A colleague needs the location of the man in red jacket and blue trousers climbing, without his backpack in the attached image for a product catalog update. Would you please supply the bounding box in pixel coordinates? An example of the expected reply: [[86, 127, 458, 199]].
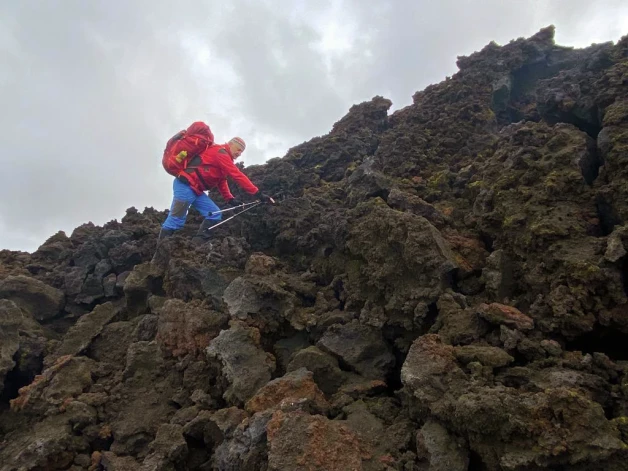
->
[[159, 137, 273, 240]]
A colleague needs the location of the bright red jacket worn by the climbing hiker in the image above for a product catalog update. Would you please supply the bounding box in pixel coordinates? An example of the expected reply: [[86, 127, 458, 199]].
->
[[181, 144, 258, 201]]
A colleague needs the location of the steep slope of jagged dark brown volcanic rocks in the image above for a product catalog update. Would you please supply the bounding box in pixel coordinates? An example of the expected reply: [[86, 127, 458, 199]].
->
[[0, 27, 628, 471]]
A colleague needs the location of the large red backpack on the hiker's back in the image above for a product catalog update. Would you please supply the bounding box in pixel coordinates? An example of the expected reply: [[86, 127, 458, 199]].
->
[[161, 121, 214, 177]]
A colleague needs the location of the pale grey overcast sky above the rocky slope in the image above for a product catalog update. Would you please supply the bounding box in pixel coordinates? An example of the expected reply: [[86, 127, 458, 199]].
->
[[0, 0, 628, 252]]
